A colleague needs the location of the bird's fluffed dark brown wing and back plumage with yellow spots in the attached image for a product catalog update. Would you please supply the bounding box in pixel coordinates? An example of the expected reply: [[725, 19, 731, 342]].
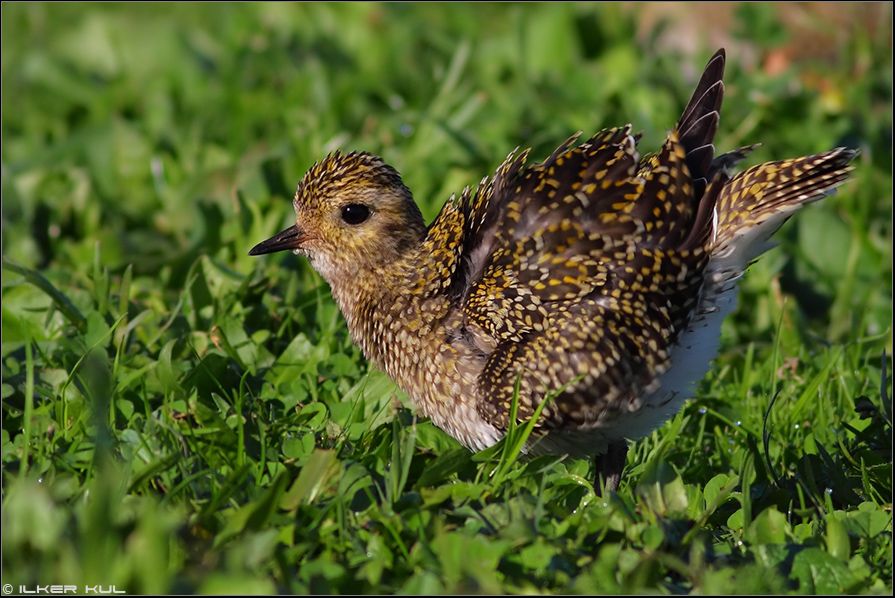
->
[[460, 127, 707, 426]]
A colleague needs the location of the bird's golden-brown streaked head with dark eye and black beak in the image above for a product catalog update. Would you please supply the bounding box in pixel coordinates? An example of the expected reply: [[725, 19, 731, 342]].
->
[[249, 152, 426, 285]]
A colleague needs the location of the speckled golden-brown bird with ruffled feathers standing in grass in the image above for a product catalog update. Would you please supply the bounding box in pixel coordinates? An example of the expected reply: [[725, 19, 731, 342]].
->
[[249, 48, 857, 492]]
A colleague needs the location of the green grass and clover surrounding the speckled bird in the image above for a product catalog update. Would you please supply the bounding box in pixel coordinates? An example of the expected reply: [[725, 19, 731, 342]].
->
[[2, 3, 892, 594]]
